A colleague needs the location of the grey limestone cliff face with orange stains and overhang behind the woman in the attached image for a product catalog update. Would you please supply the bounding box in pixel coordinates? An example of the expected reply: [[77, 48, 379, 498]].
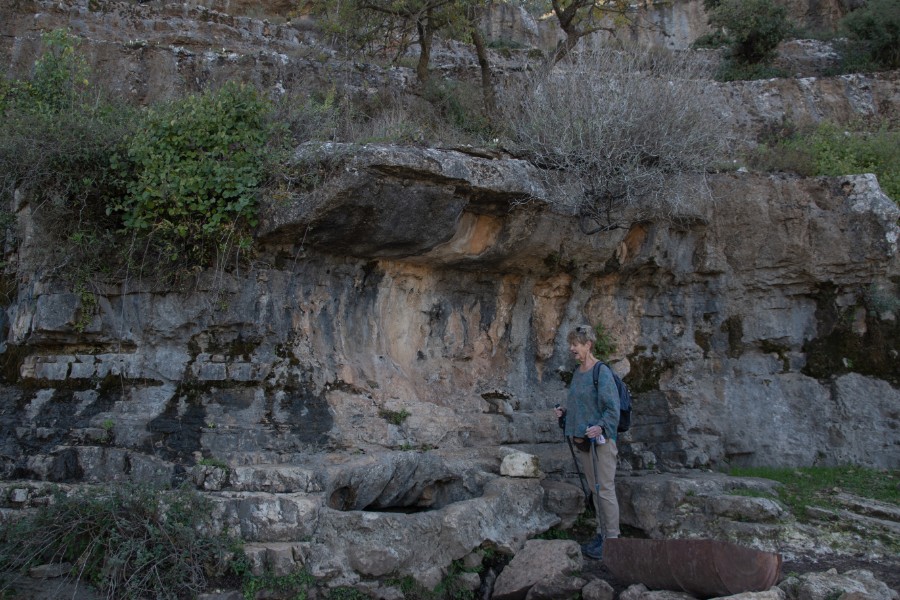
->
[[3, 141, 900, 480]]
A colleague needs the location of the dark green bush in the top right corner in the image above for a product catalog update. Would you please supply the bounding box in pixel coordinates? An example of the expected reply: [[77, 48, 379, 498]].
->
[[841, 0, 900, 69]]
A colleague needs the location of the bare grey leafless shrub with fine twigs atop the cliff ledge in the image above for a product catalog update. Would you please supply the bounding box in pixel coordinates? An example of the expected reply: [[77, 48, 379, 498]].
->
[[501, 47, 723, 233]]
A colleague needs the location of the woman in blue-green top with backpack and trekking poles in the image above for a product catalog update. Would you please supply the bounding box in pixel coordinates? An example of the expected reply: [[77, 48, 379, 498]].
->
[[556, 325, 619, 559]]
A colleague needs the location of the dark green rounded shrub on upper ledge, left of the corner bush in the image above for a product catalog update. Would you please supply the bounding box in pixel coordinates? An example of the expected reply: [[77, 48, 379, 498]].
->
[[709, 0, 792, 64]]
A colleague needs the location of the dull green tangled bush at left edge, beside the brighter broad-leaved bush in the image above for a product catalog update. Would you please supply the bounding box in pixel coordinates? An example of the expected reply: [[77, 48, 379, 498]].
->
[[0, 30, 136, 273]]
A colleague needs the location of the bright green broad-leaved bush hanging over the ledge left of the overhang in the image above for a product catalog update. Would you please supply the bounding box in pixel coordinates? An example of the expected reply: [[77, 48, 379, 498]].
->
[[109, 83, 272, 266]]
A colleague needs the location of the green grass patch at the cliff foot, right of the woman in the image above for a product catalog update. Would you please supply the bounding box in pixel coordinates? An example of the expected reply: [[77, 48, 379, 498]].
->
[[729, 466, 900, 519]]
